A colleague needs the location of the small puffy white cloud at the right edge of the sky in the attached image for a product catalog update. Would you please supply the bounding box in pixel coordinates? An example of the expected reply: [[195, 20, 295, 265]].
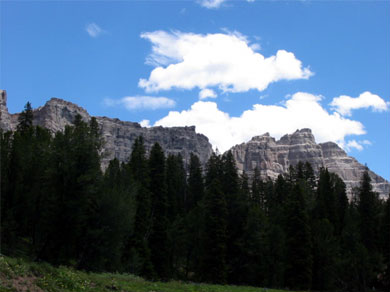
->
[[330, 91, 390, 116]]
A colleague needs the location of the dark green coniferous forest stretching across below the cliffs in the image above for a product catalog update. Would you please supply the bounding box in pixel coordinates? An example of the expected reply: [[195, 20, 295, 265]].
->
[[0, 104, 390, 291]]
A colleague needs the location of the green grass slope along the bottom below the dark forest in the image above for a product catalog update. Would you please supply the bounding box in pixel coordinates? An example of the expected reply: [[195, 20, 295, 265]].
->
[[0, 256, 292, 292]]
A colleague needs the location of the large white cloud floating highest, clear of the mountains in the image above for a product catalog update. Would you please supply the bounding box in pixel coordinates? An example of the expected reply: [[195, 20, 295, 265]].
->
[[138, 31, 313, 96]]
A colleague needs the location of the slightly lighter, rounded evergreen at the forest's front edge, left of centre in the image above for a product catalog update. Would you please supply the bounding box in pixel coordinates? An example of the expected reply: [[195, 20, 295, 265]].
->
[[79, 159, 135, 271]]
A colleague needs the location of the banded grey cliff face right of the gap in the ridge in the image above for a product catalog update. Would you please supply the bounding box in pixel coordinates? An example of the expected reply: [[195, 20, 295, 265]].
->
[[231, 129, 390, 197]]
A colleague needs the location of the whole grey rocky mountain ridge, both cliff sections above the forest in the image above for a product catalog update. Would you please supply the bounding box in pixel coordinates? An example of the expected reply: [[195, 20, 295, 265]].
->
[[0, 90, 390, 197]]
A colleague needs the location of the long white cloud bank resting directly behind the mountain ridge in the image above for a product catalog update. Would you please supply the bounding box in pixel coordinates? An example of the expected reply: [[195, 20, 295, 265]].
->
[[155, 92, 365, 151]]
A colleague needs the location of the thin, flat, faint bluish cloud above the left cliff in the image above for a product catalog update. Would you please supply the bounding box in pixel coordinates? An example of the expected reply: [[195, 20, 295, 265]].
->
[[104, 96, 176, 110]]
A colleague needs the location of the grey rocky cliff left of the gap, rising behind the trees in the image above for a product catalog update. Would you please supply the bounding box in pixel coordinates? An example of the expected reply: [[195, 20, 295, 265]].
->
[[0, 91, 212, 167]]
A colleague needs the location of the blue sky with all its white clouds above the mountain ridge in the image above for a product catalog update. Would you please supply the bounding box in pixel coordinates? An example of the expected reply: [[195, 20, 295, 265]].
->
[[0, 0, 390, 180]]
